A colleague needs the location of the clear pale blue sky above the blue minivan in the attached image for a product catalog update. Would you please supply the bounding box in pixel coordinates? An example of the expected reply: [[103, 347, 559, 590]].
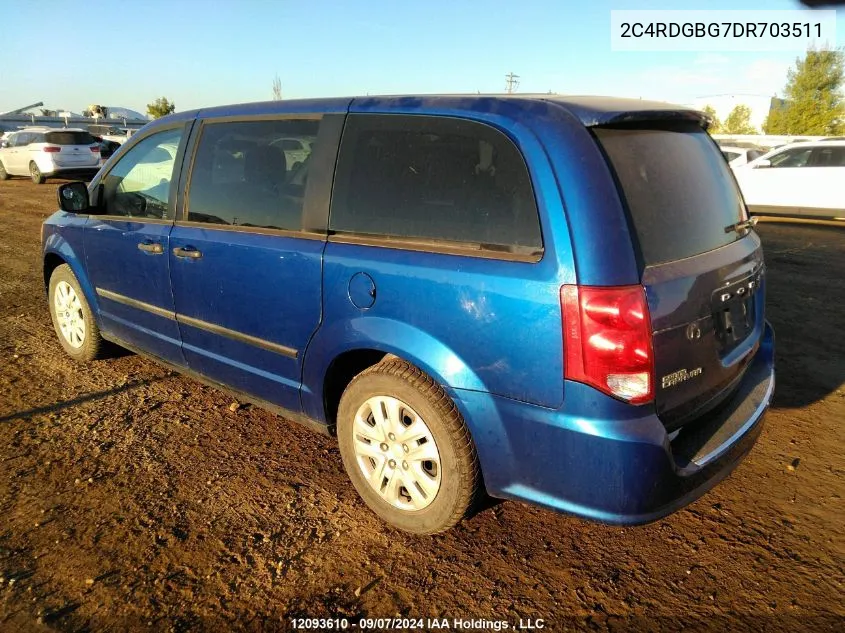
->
[[0, 0, 845, 112]]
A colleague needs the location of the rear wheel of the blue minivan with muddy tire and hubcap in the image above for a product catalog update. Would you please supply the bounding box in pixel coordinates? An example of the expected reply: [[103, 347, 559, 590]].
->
[[337, 357, 483, 534]]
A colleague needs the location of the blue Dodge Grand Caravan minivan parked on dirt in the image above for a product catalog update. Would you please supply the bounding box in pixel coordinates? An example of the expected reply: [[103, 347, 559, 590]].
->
[[42, 95, 774, 534]]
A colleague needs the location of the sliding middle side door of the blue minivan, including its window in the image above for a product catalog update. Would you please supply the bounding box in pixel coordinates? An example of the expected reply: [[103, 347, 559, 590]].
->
[[168, 117, 340, 411]]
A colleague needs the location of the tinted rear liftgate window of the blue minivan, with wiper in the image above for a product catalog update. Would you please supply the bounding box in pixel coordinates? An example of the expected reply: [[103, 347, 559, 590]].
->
[[593, 124, 745, 266]]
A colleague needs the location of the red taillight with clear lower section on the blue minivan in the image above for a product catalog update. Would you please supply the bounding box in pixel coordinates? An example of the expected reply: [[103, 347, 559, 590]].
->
[[560, 285, 654, 404]]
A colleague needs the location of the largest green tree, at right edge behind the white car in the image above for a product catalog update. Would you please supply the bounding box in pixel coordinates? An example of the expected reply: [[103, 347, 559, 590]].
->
[[765, 49, 845, 136]]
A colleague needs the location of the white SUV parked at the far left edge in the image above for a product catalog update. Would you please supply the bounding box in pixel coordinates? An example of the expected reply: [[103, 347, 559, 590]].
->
[[0, 127, 100, 185]]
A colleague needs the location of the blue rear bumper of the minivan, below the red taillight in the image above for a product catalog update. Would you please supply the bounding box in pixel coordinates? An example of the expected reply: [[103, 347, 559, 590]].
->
[[455, 323, 775, 525]]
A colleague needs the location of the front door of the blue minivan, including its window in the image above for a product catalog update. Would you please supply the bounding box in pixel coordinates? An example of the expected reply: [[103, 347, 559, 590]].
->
[[84, 122, 191, 364]]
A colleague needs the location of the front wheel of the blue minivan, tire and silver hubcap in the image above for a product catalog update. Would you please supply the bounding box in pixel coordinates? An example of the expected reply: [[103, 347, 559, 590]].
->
[[48, 264, 104, 363]]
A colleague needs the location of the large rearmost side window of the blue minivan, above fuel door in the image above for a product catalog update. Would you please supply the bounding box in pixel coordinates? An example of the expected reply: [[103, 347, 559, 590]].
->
[[330, 115, 542, 252]]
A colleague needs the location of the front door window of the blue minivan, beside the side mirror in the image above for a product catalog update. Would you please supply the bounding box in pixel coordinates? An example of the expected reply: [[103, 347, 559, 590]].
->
[[100, 128, 182, 218]]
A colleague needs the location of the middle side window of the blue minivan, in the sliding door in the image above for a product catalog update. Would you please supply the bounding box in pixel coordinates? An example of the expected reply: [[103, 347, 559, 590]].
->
[[188, 120, 320, 230]]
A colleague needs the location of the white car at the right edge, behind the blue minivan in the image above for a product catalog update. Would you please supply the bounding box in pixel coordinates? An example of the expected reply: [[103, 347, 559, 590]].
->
[[734, 141, 845, 218]]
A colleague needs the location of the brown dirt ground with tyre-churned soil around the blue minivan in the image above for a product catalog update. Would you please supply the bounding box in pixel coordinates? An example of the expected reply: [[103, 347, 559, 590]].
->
[[0, 180, 845, 631]]
